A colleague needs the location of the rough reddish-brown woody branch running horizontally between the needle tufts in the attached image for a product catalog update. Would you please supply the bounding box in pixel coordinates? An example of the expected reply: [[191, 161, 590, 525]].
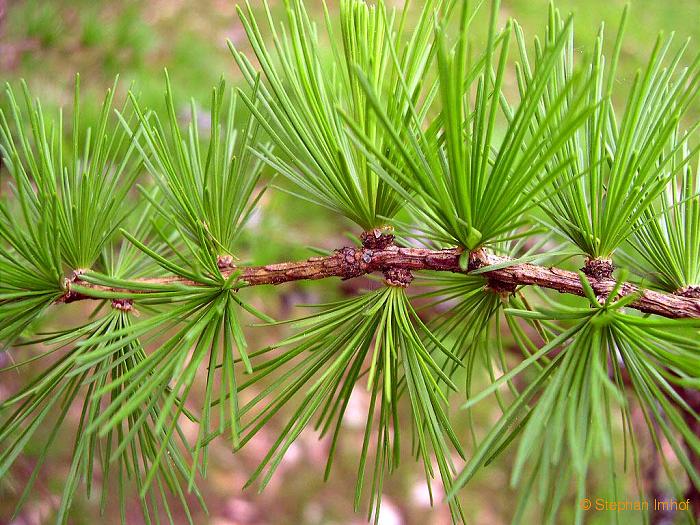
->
[[57, 244, 700, 318]]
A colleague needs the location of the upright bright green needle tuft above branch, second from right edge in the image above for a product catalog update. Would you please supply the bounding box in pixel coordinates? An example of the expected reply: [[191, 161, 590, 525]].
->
[[532, 4, 700, 258]]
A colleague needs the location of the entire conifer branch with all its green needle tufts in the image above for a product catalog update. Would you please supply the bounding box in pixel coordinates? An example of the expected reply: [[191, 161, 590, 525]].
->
[[0, 0, 700, 523]]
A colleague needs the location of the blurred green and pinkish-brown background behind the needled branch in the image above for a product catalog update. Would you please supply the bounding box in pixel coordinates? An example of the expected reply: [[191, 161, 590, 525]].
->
[[0, 0, 700, 525]]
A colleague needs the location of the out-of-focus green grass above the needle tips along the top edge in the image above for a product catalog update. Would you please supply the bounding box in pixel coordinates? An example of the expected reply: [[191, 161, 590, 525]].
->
[[0, 0, 700, 119]]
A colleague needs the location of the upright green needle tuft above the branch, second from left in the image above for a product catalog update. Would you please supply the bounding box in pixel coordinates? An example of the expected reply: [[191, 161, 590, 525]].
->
[[126, 72, 262, 260]]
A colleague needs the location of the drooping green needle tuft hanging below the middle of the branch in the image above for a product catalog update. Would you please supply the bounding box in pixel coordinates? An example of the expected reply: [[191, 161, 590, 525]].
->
[[243, 286, 464, 520]]
